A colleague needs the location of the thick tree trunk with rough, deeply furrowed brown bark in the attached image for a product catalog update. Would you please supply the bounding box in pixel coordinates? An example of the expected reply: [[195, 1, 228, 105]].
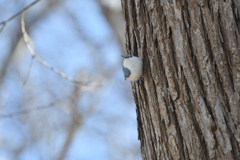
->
[[122, 0, 240, 160]]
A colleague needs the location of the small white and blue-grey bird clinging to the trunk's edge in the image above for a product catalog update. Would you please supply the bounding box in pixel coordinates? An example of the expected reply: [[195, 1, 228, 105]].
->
[[122, 55, 143, 81]]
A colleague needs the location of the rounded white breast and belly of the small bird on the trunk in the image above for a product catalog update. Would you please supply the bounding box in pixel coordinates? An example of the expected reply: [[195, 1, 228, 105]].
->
[[123, 56, 143, 81]]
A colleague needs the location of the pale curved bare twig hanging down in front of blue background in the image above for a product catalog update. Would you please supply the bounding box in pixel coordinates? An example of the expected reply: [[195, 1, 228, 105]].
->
[[21, 12, 81, 84]]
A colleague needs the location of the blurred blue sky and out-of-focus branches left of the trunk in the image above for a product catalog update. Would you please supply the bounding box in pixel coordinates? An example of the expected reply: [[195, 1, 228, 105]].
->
[[0, 0, 141, 160]]
